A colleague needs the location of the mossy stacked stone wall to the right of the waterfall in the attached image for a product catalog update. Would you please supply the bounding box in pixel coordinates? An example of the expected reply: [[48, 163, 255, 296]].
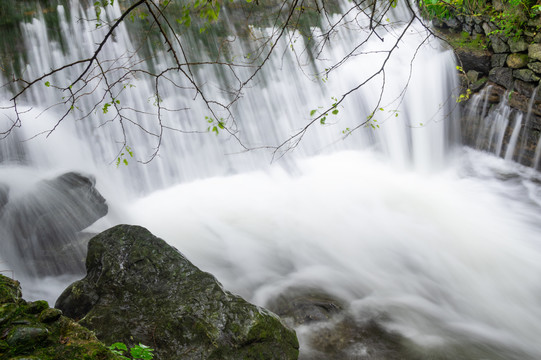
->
[[433, 10, 541, 169]]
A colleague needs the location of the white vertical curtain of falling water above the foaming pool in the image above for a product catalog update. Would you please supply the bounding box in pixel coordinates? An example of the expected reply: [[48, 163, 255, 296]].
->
[[3, 1, 457, 192]]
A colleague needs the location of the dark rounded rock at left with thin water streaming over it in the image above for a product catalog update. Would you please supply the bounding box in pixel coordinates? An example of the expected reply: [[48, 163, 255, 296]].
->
[[0, 172, 108, 276]]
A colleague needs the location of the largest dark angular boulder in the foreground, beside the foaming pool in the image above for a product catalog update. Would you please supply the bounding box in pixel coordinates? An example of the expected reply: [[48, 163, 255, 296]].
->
[[56, 225, 299, 360]]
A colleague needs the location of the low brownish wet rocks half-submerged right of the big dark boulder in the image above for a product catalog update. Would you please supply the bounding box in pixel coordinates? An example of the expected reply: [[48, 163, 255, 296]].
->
[[266, 288, 419, 360]]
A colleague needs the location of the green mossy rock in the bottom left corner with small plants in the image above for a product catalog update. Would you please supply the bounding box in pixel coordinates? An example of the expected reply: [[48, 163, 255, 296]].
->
[[0, 275, 120, 360]]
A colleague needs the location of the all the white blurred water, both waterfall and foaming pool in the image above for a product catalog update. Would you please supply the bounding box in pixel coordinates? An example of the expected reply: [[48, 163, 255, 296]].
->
[[0, 1, 541, 359]]
